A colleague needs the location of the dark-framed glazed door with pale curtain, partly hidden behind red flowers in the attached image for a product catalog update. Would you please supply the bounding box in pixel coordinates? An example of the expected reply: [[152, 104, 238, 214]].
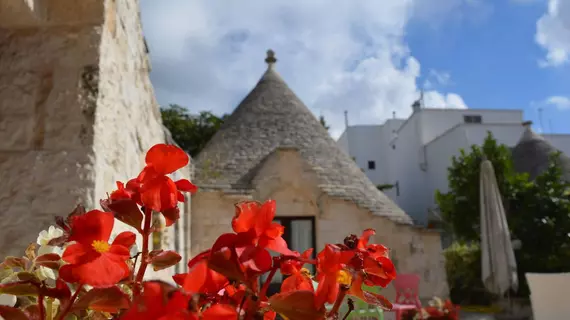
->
[[260, 217, 317, 296]]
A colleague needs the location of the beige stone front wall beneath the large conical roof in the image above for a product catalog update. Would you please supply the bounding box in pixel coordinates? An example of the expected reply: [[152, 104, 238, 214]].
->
[[191, 149, 448, 299]]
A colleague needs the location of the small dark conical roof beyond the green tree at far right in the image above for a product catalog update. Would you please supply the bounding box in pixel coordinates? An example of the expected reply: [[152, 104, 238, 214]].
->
[[512, 125, 570, 181]]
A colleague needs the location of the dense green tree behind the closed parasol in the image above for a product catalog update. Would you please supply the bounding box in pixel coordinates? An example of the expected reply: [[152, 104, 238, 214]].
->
[[436, 134, 570, 300]]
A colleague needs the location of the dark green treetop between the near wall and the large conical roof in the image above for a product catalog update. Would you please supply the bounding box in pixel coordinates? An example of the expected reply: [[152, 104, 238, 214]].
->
[[160, 104, 228, 157]]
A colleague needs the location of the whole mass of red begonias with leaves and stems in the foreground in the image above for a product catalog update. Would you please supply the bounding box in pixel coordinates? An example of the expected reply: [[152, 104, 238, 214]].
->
[[0, 144, 396, 320]]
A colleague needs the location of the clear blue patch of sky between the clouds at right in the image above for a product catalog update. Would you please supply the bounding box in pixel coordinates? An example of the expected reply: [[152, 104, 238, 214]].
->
[[406, 1, 570, 133]]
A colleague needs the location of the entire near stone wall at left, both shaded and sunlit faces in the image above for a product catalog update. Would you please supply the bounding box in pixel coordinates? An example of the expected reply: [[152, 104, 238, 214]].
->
[[0, 0, 190, 275]]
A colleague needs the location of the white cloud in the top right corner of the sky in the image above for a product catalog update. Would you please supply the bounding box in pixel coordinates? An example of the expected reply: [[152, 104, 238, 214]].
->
[[535, 0, 570, 67]]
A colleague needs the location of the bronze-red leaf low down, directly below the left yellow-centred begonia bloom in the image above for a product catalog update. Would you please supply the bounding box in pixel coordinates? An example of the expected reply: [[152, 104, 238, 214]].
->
[[72, 287, 130, 313]]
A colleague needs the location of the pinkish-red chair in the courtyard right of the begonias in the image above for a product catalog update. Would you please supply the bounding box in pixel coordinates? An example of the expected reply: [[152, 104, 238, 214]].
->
[[386, 274, 423, 320]]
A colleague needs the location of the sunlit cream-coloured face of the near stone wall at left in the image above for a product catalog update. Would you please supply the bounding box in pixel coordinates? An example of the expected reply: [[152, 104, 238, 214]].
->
[[93, 0, 190, 280]]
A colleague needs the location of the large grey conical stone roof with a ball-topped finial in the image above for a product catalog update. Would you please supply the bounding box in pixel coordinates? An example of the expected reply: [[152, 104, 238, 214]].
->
[[194, 51, 412, 224]]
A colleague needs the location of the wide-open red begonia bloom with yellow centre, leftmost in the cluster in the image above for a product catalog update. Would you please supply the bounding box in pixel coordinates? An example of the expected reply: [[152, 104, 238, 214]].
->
[[59, 210, 136, 287]]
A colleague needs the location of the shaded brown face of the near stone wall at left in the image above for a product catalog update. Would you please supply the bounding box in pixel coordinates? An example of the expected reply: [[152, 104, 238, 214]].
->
[[0, 0, 100, 256]]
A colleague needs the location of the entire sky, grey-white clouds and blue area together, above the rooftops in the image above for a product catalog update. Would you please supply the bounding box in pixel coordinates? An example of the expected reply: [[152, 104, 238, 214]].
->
[[141, 0, 570, 136]]
